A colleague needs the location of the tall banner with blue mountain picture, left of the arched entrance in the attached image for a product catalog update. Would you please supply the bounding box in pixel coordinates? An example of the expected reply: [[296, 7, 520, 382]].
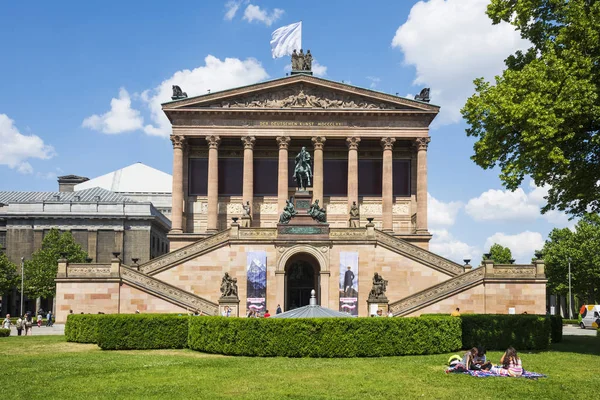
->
[[246, 251, 267, 314]]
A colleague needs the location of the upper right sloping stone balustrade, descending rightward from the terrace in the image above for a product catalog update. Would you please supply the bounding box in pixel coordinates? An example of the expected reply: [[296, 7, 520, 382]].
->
[[375, 230, 465, 276]]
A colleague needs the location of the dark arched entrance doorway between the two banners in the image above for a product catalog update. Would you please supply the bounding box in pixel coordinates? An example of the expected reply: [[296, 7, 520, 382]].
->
[[285, 253, 321, 311]]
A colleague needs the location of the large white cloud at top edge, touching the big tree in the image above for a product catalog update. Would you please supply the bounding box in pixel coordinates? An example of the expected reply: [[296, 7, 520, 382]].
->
[[392, 0, 529, 125]]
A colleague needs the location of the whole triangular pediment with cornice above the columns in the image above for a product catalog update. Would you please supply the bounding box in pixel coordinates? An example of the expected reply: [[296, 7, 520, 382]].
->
[[163, 75, 439, 114]]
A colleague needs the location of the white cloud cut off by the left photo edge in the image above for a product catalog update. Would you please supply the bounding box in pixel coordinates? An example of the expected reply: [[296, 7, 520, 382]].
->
[[0, 114, 55, 174]]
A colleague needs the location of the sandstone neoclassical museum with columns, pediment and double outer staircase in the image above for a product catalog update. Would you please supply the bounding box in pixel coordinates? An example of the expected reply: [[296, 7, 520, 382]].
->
[[56, 63, 546, 321]]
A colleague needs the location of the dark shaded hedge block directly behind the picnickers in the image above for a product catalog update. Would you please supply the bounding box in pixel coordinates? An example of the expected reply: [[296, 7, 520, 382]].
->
[[460, 314, 562, 350]]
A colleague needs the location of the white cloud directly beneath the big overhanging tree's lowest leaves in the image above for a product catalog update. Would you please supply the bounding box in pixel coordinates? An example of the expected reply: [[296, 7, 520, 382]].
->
[[465, 181, 576, 227]]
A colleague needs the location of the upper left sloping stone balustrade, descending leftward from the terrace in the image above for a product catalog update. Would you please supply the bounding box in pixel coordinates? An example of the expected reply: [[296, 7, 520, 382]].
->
[[139, 229, 230, 275]]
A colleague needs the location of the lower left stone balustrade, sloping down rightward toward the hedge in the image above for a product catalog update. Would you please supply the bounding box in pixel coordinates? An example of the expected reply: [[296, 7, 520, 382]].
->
[[121, 265, 219, 315]]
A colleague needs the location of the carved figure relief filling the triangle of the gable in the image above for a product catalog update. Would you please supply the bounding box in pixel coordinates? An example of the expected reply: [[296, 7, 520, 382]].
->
[[200, 86, 406, 110]]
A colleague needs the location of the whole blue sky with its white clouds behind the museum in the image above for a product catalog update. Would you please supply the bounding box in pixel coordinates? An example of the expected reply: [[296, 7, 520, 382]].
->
[[0, 0, 573, 262]]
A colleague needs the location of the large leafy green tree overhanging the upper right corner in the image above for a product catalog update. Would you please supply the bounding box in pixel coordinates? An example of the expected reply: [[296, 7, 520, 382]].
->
[[462, 0, 600, 216]]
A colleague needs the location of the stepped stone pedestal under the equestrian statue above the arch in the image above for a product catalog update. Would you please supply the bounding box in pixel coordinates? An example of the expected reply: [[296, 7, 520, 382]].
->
[[277, 190, 329, 240]]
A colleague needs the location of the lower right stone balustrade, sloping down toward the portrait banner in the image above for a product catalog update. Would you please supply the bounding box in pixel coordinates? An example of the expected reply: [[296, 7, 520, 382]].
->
[[389, 267, 485, 317]]
